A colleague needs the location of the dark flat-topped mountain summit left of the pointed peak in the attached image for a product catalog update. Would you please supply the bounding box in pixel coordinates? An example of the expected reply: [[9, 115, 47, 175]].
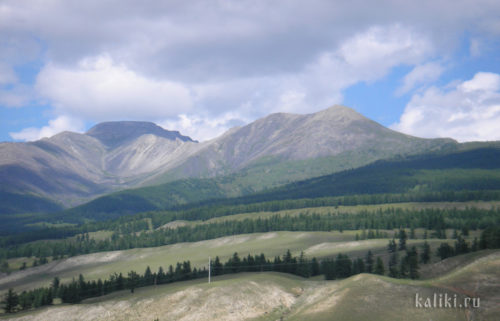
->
[[86, 121, 194, 147]]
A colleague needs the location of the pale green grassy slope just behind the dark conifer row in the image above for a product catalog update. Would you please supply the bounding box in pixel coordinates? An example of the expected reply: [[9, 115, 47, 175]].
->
[[0, 231, 451, 293]]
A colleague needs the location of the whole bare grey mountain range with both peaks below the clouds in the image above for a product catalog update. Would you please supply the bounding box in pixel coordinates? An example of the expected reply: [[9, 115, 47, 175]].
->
[[0, 106, 459, 212]]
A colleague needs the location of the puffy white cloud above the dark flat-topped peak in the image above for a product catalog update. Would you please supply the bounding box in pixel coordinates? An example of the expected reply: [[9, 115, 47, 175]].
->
[[36, 55, 192, 121]]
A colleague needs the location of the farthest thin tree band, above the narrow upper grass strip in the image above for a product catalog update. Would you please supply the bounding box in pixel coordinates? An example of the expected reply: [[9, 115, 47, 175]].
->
[[0, 190, 500, 248]]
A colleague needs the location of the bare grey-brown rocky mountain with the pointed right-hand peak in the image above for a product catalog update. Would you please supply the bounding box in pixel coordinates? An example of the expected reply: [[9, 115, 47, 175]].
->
[[146, 106, 456, 182]]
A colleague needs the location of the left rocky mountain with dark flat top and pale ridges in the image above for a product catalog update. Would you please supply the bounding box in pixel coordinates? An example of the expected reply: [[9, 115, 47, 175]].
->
[[0, 122, 196, 205]]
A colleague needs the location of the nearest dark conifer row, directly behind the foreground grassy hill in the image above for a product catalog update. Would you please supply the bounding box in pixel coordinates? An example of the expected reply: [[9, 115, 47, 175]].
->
[[4, 222, 500, 313]]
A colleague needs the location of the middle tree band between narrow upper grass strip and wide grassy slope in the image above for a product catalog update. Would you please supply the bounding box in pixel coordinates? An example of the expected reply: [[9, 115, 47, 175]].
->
[[0, 208, 500, 261]]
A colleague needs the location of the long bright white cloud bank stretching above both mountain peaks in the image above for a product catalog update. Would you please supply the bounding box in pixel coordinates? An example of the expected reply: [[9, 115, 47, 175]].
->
[[23, 25, 432, 140]]
